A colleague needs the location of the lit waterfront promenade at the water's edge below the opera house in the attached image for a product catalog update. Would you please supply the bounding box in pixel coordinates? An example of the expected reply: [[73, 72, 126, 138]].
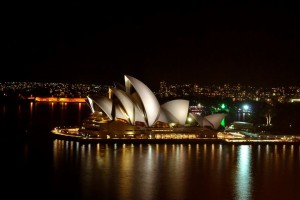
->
[[51, 127, 300, 145]]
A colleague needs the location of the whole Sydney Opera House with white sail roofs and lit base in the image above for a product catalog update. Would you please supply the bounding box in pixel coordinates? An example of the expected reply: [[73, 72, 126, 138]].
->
[[79, 75, 226, 139]]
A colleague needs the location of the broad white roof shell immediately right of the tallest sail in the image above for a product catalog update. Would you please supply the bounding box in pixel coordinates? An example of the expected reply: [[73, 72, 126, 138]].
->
[[161, 99, 189, 125]]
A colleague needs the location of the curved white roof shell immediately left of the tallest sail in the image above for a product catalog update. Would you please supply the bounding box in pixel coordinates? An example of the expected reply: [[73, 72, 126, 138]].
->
[[110, 88, 135, 124]]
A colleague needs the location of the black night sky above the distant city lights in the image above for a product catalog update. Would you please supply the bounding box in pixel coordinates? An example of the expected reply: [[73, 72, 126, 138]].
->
[[0, 1, 300, 88]]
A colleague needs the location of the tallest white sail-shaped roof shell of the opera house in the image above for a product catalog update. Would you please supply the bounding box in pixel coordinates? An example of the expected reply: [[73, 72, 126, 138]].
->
[[125, 75, 160, 127]]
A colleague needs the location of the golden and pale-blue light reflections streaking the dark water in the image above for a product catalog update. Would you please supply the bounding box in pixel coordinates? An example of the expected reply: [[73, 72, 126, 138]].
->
[[53, 140, 300, 199]]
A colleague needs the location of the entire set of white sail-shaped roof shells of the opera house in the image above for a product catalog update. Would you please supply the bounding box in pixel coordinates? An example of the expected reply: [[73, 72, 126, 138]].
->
[[86, 76, 226, 130]]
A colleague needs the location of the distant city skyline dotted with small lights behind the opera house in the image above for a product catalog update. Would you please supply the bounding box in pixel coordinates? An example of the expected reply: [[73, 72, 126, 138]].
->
[[0, 81, 300, 104]]
